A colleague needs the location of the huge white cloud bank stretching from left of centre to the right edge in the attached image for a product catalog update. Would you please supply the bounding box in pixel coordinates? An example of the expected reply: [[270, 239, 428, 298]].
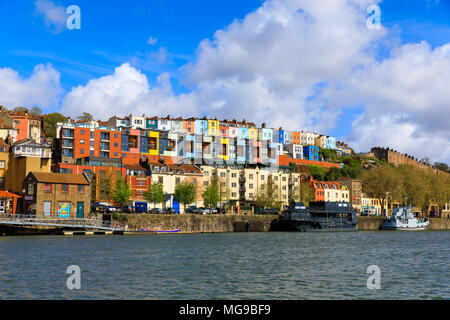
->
[[56, 0, 450, 162]]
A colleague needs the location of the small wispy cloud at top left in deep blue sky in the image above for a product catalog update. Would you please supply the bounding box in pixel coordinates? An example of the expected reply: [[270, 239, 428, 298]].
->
[[34, 0, 67, 33]]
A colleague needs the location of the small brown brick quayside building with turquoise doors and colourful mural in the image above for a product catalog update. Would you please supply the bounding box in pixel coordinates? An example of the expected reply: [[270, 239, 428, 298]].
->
[[23, 171, 91, 219]]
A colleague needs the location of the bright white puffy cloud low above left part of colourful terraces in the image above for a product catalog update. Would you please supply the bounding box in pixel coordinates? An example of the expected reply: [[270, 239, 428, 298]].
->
[[61, 63, 199, 119]]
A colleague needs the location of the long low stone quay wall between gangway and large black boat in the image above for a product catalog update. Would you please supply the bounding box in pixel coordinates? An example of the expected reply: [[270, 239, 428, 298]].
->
[[118, 214, 278, 233]]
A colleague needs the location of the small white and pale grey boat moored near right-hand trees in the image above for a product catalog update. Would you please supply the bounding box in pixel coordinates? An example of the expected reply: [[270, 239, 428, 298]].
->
[[382, 207, 430, 230]]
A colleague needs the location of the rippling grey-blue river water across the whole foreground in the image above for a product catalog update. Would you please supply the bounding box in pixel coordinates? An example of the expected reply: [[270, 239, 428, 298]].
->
[[0, 231, 450, 300]]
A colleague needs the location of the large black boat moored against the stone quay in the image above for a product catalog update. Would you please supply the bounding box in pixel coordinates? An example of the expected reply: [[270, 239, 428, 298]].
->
[[271, 201, 356, 231]]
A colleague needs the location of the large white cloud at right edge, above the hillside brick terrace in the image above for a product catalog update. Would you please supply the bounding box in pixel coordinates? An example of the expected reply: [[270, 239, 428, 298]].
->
[[326, 42, 450, 162]]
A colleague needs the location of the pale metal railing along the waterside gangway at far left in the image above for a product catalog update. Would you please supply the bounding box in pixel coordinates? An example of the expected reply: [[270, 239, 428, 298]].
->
[[0, 214, 123, 230]]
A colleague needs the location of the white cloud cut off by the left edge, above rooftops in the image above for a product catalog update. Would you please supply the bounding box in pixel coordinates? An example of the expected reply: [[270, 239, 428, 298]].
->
[[0, 64, 63, 108]]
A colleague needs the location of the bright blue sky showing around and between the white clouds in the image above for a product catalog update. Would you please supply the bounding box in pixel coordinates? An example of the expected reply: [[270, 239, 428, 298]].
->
[[0, 0, 450, 159]]
